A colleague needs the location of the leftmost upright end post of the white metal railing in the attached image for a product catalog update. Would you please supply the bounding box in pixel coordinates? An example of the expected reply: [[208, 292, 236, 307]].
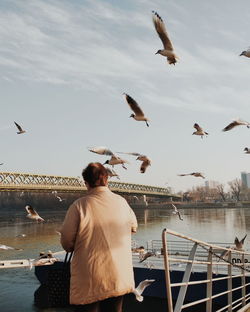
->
[[162, 229, 173, 312]]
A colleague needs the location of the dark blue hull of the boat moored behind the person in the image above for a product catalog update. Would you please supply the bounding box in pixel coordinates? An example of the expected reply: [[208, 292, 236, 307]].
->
[[35, 262, 250, 312]]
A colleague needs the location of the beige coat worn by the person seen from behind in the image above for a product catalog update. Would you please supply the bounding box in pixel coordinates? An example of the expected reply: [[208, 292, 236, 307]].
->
[[61, 186, 137, 305]]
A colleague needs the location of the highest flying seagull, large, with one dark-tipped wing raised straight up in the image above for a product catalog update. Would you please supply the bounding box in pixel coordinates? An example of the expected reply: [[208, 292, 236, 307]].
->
[[152, 11, 177, 65]]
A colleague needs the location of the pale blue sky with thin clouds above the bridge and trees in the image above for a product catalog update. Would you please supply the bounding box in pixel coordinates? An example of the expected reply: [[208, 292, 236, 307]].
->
[[0, 0, 250, 191]]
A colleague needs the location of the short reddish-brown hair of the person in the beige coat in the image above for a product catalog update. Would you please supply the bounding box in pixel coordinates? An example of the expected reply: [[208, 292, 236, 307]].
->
[[82, 163, 108, 188]]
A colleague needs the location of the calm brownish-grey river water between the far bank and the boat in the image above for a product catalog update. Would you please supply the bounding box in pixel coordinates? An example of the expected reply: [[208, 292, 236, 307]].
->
[[0, 207, 250, 312]]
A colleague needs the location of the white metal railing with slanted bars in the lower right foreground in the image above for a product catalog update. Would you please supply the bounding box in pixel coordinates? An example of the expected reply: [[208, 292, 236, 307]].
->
[[162, 229, 250, 312]]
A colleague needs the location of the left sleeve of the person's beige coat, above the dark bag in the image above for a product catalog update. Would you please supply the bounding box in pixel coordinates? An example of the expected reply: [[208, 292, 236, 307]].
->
[[60, 204, 80, 252]]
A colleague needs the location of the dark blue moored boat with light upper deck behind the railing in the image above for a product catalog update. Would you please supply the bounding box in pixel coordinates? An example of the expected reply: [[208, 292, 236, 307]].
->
[[35, 230, 250, 312]]
